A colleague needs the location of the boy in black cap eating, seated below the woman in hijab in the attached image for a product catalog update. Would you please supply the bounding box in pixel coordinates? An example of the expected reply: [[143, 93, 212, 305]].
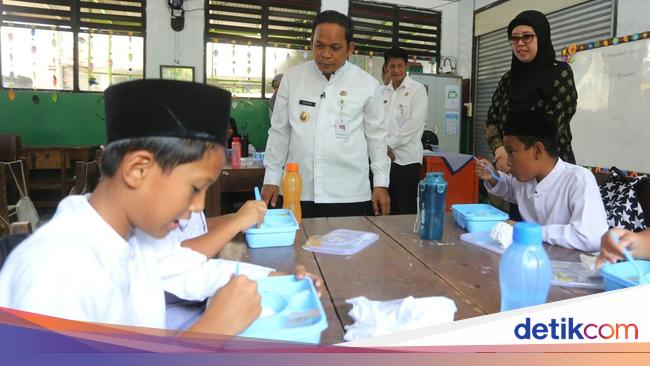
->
[[476, 111, 608, 252]]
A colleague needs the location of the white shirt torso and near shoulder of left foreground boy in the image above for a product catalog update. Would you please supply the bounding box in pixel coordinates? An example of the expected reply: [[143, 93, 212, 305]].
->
[[0, 195, 165, 328]]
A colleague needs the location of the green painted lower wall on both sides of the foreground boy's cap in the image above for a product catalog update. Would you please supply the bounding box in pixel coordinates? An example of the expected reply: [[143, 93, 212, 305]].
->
[[0, 89, 270, 150]]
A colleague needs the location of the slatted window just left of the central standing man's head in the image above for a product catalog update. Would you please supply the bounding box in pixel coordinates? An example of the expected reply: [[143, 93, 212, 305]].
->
[[205, 0, 320, 98]]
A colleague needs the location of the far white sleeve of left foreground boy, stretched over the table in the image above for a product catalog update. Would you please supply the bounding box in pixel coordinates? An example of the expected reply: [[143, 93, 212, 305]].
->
[[157, 247, 274, 301]]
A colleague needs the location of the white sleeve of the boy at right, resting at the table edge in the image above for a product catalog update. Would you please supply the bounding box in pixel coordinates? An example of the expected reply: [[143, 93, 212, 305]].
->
[[543, 173, 608, 252]]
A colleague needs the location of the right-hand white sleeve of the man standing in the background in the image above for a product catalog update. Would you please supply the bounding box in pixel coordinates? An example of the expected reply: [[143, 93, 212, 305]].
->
[[387, 85, 429, 149]]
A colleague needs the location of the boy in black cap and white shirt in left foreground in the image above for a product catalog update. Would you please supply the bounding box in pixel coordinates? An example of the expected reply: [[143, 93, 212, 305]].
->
[[0, 80, 318, 335]]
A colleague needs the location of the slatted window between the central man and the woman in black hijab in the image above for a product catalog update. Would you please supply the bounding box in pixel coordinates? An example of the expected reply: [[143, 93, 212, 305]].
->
[[349, 1, 441, 79]]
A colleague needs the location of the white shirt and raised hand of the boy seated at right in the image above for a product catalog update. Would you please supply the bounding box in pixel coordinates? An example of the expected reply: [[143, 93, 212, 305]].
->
[[484, 158, 609, 252]]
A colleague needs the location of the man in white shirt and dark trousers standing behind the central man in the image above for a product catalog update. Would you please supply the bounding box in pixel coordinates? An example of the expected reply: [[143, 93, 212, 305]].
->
[[382, 48, 429, 214]]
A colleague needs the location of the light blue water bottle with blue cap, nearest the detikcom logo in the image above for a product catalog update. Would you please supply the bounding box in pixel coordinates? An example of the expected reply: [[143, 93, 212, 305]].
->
[[499, 222, 551, 311]]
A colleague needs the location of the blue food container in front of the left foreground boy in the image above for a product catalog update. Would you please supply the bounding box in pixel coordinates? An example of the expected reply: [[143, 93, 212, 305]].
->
[[239, 275, 327, 344]]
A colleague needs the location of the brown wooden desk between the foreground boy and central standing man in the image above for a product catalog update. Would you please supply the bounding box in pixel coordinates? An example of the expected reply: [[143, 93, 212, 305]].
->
[[205, 159, 264, 217]]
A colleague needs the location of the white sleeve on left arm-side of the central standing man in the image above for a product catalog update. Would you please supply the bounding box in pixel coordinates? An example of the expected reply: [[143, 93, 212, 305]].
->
[[264, 73, 291, 186]]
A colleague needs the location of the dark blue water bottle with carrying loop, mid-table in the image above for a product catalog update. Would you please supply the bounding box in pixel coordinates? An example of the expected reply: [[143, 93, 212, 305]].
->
[[418, 172, 447, 240]]
